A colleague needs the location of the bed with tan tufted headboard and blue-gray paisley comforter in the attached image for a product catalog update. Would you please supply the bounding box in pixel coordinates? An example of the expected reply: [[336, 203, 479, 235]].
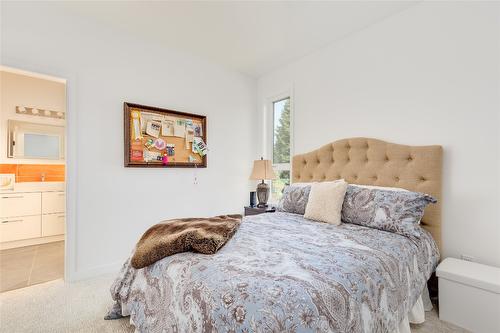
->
[[111, 138, 442, 332]]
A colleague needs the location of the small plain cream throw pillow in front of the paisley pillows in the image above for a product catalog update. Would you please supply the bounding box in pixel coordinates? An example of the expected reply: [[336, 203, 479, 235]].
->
[[304, 179, 347, 225]]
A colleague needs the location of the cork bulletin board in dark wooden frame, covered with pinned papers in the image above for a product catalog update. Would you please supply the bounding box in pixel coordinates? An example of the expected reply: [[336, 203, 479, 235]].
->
[[123, 102, 207, 168]]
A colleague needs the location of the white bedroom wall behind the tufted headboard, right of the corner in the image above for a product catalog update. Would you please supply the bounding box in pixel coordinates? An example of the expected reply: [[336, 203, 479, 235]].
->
[[258, 2, 500, 266]]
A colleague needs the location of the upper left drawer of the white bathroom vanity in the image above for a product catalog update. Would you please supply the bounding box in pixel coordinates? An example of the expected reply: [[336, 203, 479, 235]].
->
[[0, 193, 41, 218]]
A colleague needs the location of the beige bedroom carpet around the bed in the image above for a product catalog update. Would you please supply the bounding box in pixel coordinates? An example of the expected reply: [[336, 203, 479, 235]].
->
[[0, 275, 466, 333]]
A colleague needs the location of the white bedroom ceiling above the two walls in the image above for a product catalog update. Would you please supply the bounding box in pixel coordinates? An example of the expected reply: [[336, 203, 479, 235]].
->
[[60, 1, 416, 77]]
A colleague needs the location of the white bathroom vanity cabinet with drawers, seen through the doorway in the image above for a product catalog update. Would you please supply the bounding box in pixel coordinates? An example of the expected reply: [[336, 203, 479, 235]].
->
[[0, 184, 66, 249]]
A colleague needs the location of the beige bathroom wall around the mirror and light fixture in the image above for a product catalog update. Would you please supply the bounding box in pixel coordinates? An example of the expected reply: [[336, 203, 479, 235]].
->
[[0, 69, 66, 164]]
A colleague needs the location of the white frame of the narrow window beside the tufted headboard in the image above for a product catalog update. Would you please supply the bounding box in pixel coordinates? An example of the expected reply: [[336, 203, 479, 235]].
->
[[264, 88, 295, 204]]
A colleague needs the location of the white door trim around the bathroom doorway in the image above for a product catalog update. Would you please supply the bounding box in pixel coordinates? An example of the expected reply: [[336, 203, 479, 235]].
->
[[0, 57, 78, 282]]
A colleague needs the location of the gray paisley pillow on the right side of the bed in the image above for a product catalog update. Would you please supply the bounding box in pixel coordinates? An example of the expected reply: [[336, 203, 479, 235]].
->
[[342, 185, 437, 238]]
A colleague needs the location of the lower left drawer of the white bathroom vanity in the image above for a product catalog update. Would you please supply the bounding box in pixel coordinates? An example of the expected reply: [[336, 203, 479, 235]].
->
[[0, 215, 42, 242]]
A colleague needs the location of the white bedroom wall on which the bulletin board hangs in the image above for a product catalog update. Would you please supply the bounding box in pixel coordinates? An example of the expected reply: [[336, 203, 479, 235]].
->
[[0, 2, 256, 279]]
